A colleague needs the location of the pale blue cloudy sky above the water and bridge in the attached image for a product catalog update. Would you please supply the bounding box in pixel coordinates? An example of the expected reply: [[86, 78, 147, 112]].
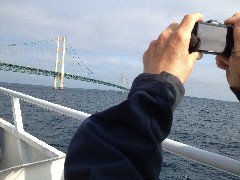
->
[[0, 0, 240, 101]]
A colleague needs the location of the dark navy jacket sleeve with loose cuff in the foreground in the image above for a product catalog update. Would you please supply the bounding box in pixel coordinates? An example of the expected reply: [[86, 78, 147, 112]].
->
[[64, 72, 184, 180]]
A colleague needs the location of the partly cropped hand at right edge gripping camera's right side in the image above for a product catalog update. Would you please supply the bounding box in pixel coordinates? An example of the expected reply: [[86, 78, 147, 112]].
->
[[216, 13, 240, 101]]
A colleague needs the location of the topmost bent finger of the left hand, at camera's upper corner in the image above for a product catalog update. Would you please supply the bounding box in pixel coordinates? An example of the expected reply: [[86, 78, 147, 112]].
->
[[179, 13, 203, 36]]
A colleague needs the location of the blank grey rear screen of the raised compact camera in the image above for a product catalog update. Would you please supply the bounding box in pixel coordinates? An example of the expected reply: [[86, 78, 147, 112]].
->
[[198, 23, 227, 53]]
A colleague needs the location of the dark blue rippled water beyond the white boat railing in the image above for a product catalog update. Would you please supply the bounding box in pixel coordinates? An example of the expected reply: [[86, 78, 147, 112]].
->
[[0, 83, 240, 180]]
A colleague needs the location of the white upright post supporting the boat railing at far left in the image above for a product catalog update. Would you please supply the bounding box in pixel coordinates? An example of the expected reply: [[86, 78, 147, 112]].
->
[[12, 97, 28, 164]]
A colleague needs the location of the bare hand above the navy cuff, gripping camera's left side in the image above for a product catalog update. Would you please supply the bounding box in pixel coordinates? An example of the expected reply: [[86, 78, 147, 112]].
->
[[143, 14, 203, 83]]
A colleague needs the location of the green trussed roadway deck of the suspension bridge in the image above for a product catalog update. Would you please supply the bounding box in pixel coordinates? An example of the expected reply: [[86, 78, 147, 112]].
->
[[0, 62, 129, 91]]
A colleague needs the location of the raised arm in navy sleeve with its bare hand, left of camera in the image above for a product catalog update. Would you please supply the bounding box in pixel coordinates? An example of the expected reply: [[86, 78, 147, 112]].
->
[[64, 13, 240, 180]]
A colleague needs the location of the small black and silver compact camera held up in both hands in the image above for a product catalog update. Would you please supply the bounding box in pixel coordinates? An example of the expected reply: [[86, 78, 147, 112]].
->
[[189, 20, 234, 57]]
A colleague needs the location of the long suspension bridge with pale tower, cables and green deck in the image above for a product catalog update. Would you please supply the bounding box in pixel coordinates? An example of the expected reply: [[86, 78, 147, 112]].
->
[[0, 36, 129, 91]]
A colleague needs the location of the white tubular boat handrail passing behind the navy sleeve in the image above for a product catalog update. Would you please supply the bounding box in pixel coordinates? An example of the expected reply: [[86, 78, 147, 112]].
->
[[0, 87, 240, 176]]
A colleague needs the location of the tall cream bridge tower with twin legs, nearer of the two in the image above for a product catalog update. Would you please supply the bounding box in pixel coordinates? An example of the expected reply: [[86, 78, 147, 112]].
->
[[53, 36, 66, 89]]
